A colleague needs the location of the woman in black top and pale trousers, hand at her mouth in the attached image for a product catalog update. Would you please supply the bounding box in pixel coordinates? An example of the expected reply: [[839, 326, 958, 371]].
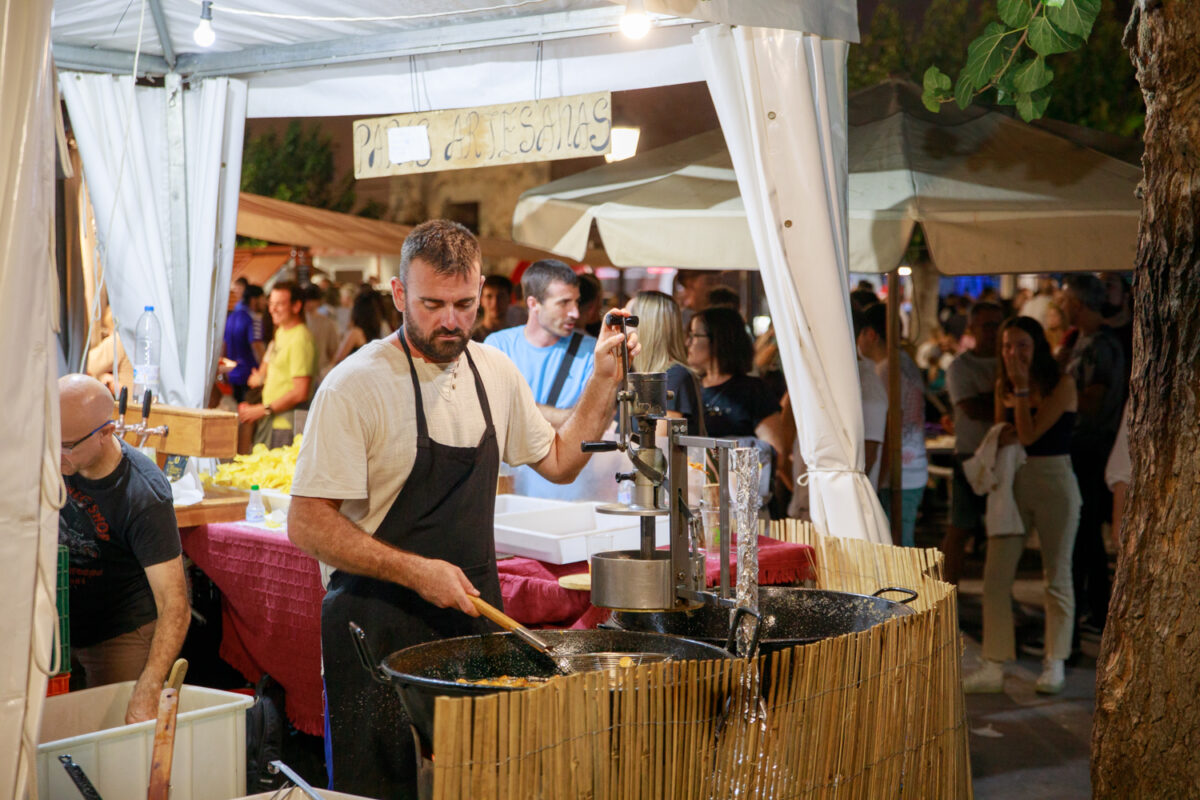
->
[[962, 317, 1081, 694]]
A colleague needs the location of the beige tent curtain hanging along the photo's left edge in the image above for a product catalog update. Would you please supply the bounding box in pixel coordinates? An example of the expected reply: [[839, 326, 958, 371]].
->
[[0, 0, 62, 798]]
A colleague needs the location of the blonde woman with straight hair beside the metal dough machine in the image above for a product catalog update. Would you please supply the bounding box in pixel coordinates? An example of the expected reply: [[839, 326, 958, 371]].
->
[[629, 291, 707, 437]]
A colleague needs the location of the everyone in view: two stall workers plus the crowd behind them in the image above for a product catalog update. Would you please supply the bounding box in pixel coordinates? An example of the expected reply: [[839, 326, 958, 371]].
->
[[59, 209, 1132, 796]]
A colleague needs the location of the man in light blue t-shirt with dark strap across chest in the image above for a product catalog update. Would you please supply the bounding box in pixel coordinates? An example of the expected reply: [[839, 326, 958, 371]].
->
[[484, 259, 596, 428]]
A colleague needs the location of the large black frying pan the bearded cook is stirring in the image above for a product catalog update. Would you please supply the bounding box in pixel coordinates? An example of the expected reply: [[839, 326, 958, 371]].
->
[[350, 622, 733, 750]]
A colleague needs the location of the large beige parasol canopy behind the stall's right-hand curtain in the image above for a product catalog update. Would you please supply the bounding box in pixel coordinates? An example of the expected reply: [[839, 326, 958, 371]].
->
[[512, 82, 1141, 275]]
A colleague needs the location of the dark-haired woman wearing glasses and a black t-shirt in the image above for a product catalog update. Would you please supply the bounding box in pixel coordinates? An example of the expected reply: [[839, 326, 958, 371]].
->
[[686, 308, 787, 465]]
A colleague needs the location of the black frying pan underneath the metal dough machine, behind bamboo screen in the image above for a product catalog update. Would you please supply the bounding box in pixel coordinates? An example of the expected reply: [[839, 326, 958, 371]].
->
[[612, 587, 917, 656]]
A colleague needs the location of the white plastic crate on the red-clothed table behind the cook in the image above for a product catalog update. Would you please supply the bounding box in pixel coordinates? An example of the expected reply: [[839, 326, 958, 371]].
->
[[496, 503, 671, 564]]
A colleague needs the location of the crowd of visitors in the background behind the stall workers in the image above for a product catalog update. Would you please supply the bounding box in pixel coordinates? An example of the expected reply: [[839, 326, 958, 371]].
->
[[223, 259, 1132, 692]]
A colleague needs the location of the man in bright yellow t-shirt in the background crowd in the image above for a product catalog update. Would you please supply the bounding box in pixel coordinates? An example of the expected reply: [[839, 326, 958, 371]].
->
[[238, 281, 317, 447]]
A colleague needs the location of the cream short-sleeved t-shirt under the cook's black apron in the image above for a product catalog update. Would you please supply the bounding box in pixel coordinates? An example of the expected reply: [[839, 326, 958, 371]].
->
[[292, 337, 554, 583]]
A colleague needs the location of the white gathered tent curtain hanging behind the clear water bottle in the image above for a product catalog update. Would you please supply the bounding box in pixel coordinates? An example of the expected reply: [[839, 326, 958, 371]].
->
[[60, 72, 246, 408]]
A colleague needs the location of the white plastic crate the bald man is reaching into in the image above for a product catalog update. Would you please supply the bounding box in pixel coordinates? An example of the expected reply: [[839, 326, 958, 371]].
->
[[37, 681, 254, 800]]
